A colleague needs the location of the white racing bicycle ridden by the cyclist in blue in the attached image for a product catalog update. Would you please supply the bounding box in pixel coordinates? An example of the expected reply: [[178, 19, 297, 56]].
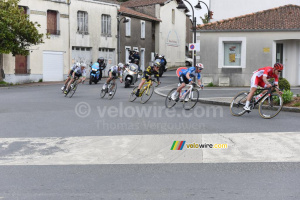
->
[[165, 83, 201, 110]]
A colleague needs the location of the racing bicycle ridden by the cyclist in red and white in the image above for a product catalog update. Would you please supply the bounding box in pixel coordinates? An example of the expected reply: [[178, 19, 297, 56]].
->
[[230, 85, 283, 119]]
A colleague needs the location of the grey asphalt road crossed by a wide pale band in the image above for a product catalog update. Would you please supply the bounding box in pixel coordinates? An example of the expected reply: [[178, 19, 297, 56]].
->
[[0, 72, 300, 199]]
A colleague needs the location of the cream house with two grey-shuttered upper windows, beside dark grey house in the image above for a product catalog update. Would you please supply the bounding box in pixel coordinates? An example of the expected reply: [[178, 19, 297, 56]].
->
[[70, 0, 120, 77]]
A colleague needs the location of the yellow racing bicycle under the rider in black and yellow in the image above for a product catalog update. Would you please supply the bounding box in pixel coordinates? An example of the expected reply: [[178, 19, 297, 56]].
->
[[129, 78, 158, 104]]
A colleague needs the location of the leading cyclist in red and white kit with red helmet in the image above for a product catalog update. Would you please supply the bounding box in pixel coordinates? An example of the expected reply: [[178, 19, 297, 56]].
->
[[244, 63, 283, 111]]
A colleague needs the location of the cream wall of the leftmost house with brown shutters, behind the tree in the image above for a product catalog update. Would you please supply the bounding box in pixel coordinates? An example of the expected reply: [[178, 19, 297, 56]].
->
[[3, 0, 69, 83]]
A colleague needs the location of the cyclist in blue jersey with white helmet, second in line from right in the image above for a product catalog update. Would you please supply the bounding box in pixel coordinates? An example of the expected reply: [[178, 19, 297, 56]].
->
[[171, 63, 204, 101]]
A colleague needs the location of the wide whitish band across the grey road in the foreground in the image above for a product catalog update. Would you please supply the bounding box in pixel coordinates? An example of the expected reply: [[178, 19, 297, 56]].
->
[[0, 132, 300, 165]]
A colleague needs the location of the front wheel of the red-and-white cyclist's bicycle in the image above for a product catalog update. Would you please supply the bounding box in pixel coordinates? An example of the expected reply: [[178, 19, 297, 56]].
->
[[259, 93, 283, 119]]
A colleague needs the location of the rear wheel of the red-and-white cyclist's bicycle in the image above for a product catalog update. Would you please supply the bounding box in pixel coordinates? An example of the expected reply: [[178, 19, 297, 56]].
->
[[230, 92, 249, 116]]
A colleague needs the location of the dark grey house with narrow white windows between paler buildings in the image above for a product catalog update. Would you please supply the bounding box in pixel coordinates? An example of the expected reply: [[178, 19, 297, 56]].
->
[[119, 6, 161, 70]]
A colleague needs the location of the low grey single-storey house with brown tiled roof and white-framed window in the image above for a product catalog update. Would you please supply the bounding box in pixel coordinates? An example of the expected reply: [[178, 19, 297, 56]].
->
[[197, 5, 300, 86]]
